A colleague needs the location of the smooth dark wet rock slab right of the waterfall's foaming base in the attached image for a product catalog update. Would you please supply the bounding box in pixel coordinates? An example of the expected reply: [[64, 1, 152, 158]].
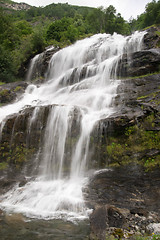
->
[[88, 164, 160, 215]]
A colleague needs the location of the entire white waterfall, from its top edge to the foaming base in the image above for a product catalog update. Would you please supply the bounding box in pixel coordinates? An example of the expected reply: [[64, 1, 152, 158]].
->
[[0, 32, 144, 219]]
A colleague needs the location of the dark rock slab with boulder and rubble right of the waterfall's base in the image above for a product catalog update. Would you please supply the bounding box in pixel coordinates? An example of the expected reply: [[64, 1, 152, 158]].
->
[[88, 165, 160, 240]]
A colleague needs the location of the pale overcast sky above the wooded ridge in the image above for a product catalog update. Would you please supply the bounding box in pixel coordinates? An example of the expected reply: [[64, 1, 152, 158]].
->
[[13, 0, 152, 20]]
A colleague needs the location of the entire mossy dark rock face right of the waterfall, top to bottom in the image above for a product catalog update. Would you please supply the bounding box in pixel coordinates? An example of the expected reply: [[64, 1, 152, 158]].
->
[[84, 26, 160, 240]]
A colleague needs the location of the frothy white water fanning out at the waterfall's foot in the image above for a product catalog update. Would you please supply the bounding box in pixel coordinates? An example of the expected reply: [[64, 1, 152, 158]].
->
[[1, 179, 88, 220]]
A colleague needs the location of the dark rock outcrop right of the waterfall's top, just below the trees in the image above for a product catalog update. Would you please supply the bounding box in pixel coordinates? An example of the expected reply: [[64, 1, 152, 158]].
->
[[117, 28, 160, 78]]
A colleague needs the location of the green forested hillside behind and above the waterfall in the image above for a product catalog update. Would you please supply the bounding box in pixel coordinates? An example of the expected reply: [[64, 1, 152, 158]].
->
[[0, 0, 160, 84]]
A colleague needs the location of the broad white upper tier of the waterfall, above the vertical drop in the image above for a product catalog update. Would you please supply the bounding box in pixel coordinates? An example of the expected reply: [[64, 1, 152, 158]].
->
[[0, 32, 145, 122]]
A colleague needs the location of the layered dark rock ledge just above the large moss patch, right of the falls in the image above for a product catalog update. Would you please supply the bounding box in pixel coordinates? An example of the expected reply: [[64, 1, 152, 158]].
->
[[96, 74, 160, 139]]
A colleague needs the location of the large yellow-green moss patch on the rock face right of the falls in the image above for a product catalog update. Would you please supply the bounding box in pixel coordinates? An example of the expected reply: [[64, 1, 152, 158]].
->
[[106, 114, 160, 170]]
